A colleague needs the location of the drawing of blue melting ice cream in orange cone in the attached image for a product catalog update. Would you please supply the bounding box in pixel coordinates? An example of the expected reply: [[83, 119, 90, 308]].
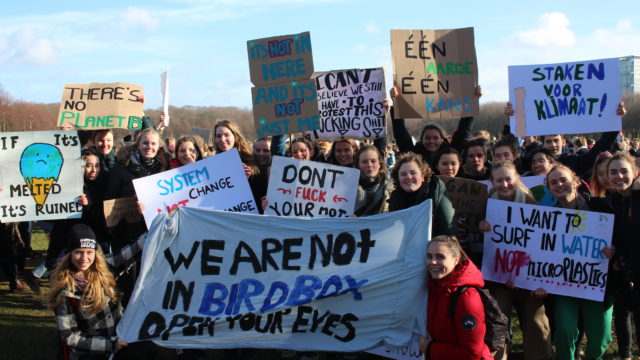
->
[[20, 143, 64, 208]]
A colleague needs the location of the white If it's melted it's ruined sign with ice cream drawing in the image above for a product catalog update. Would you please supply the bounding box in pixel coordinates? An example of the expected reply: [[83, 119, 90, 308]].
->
[[0, 131, 83, 222]]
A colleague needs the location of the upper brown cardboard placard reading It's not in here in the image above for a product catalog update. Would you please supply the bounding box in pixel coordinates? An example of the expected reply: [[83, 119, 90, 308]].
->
[[247, 31, 313, 86]]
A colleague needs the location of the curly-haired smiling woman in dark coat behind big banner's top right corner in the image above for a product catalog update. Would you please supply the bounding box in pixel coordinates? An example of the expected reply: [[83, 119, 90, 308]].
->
[[388, 152, 456, 236]]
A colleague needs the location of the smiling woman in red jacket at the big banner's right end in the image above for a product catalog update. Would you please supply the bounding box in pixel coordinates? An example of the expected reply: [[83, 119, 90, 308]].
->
[[421, 235, 493, 360]]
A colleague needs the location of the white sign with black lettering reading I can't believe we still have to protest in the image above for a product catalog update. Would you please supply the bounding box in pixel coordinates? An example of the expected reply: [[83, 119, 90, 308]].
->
[[305, 68, 387, 141]]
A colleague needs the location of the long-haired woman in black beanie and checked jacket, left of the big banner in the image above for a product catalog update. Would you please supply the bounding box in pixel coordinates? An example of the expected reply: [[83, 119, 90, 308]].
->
[[46, 224, 146, 360]]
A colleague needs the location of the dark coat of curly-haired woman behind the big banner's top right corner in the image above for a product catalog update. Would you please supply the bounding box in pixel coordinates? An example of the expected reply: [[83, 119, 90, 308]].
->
[[388, 175, 457, 237]]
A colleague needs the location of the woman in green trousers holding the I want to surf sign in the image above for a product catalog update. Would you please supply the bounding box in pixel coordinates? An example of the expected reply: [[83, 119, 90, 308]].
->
[[545, 164, 614, 359]]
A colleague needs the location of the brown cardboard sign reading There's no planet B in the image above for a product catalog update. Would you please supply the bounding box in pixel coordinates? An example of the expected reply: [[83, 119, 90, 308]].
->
[[57, 83, 144, 130]]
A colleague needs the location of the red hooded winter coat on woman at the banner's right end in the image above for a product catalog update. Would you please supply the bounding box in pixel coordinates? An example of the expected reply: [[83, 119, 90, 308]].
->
[[426, 259, 493, 360]]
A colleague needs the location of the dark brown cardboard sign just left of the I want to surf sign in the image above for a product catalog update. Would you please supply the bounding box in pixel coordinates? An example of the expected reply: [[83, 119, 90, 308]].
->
[[440, 175, 488, 232]]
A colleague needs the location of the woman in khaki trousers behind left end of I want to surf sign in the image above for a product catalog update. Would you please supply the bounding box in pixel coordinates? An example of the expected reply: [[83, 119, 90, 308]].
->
[[478, 161, 553, 360]]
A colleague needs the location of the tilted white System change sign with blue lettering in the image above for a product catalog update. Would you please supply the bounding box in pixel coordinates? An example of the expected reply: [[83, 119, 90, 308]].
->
[[133, 148, 258, 227]]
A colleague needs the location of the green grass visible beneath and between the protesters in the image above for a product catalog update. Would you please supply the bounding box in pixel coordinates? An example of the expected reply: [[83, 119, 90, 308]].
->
[[0, 228, 639, 360]]
